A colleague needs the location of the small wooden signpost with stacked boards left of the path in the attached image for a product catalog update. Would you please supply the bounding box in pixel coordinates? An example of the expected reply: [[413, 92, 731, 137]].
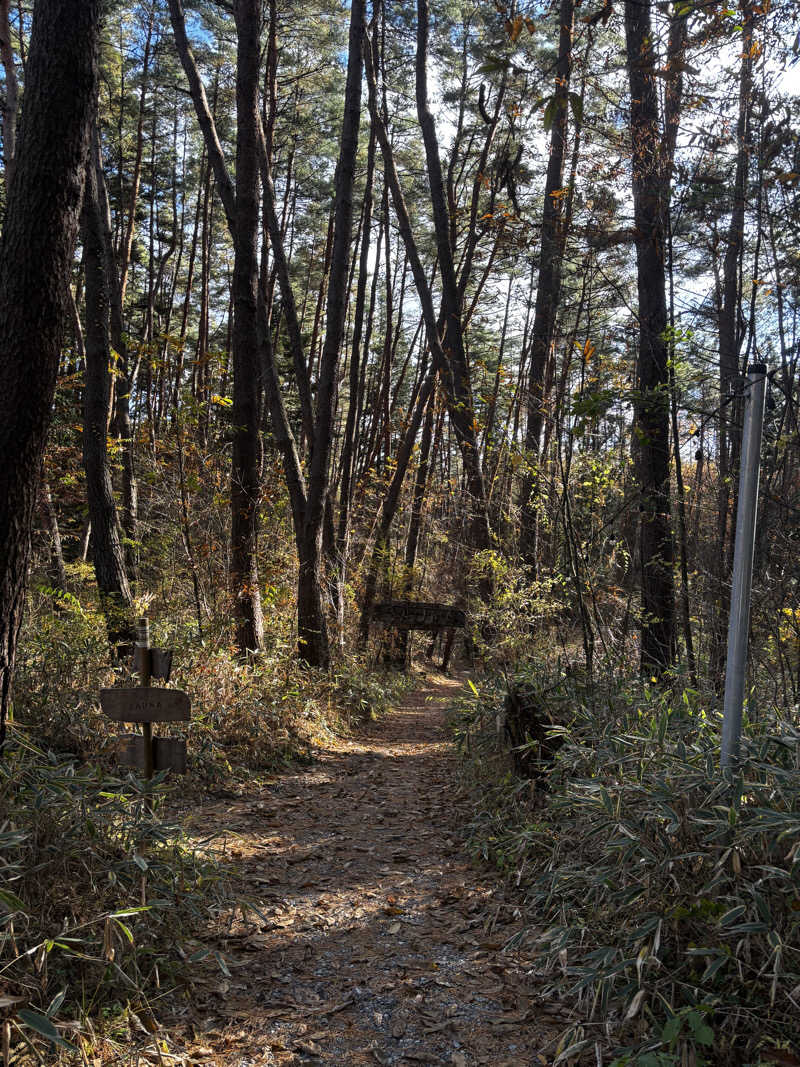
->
[[100, 619, 190, 778]]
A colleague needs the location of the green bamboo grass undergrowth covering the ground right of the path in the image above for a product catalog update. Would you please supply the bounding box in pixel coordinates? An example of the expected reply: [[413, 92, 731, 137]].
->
[[455, 667, 800, 1067]]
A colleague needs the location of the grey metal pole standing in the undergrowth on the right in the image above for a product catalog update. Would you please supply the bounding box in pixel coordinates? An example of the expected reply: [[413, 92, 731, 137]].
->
[[722, 363, 767, 768]]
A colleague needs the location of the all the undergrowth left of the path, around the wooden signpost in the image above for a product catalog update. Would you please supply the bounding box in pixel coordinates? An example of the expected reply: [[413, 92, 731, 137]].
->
[[0, 590, 412, 1065]]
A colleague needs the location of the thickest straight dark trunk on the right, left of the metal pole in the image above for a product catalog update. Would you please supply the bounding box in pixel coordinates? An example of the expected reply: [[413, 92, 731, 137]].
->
[[625, 0, 675, 674]]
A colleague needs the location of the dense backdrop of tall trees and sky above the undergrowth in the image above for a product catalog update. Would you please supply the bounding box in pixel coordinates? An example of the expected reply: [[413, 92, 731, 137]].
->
[[3, 0, 798, 695]]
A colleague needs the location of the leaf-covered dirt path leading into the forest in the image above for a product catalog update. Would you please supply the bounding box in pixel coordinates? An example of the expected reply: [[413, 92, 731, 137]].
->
[[166, 676, 561, 1067]]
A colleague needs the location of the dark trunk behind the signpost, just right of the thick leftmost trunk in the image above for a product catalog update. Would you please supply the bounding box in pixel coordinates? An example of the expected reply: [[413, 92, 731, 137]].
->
[[81, 131, 133, 644]]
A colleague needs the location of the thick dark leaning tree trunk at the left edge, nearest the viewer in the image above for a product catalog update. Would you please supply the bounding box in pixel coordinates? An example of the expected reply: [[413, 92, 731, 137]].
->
[[0, 0, 101, 750]]
